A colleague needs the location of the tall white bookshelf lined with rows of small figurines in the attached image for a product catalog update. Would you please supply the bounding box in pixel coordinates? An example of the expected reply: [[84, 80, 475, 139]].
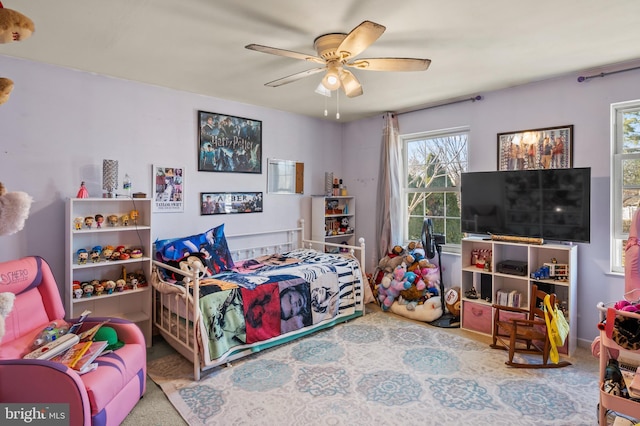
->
[[65, 198, 153, 345]]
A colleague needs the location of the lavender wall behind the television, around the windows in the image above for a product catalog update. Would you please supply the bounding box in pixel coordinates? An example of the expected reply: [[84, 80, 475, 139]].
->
[[343, 63, 640, 344]]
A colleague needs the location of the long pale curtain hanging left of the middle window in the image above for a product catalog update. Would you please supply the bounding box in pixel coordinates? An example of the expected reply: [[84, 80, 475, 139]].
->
[[376, 112, 402, 259]]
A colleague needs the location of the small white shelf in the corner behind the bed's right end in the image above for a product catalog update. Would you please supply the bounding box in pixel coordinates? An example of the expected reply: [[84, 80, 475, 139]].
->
[[311, 195, 356, 251]]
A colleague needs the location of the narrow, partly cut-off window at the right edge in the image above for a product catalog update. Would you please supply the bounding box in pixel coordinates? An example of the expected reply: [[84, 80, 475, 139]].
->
[[611, 100, 640, 272]]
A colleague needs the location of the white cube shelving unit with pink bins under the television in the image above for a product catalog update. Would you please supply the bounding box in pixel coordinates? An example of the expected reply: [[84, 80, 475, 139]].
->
[[461, 237, 578, 355]]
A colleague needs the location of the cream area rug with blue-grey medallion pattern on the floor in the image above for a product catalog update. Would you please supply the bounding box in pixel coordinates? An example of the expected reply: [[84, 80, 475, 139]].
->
[[148, 312, 598, 426]]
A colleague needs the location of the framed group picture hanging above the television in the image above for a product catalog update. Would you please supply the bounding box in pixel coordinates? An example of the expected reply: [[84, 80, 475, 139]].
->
[[498, 125, 573, 170]]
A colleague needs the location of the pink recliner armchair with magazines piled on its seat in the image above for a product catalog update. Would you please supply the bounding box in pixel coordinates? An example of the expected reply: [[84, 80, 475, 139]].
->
[[0, 257, 147, 425]]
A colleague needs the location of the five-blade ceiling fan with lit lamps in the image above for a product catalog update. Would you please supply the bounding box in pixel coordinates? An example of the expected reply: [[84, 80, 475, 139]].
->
[[245, 21, 431, 98]]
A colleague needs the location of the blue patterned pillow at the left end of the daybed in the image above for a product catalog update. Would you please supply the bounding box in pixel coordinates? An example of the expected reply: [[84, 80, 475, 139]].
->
[[156, 224, 234, 275]]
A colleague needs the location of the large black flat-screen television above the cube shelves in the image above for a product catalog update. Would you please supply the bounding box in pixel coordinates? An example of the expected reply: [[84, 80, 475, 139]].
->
[[460, 167, 591, 243]]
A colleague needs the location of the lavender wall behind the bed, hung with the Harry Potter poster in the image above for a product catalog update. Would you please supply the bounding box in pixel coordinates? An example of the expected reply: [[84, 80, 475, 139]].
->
[[0, 56, 343, 288]]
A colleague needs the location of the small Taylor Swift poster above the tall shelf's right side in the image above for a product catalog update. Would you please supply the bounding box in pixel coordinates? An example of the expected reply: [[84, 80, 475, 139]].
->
[[153, 165, 184, 213]]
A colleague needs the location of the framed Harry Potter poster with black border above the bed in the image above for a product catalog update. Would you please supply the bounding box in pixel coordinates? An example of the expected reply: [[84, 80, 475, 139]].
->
[[198, 111, 262, 173]]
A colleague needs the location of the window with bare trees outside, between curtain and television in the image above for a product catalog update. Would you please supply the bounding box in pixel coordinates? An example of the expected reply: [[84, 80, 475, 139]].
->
[[400, 128, 469, 252]]
